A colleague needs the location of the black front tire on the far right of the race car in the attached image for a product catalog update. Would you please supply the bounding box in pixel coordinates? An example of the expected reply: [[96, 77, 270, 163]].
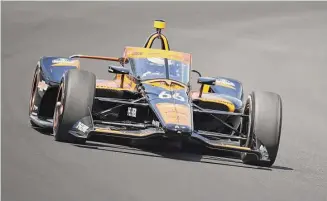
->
[[241, 92, 282, 167]]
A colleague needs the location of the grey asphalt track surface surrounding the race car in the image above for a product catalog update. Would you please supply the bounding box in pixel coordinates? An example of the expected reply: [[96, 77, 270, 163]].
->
[[1, 2, 327, 201]]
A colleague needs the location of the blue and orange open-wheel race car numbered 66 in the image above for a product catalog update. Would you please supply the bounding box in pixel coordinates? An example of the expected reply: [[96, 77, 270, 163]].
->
[[29, 20, 282, 166]]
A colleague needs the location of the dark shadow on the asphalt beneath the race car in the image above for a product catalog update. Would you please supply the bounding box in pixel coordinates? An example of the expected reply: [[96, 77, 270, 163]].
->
[[73, 137, 293, 171]]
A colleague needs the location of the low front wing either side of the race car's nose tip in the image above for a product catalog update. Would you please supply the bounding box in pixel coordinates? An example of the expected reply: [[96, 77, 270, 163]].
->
[[70, 107, 262, 159]]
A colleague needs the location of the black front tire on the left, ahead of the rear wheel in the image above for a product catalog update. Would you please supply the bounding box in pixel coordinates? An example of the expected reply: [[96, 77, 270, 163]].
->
[[53, 69, 96, 144]]
